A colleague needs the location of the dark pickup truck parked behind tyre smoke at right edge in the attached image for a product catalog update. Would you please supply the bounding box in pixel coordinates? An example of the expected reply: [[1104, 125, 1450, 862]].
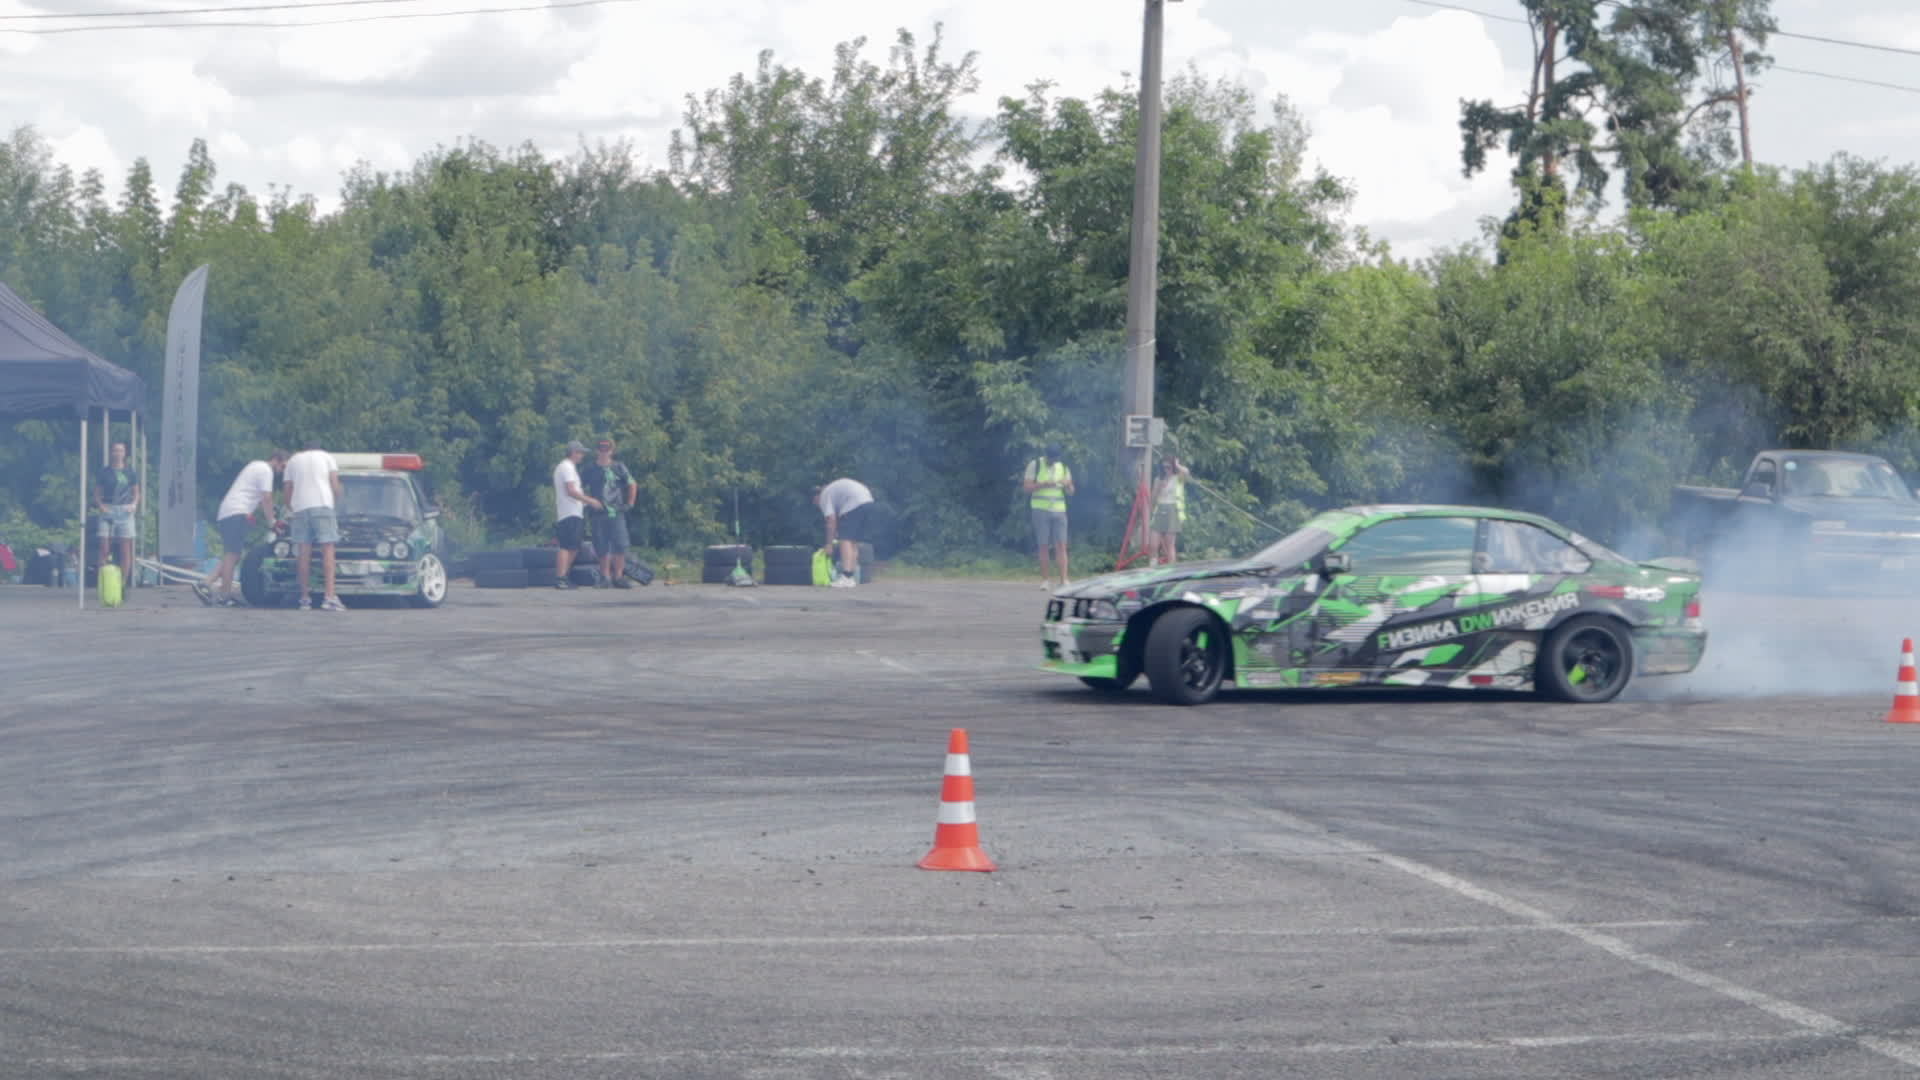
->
[[1668, 450, 1920, 586]]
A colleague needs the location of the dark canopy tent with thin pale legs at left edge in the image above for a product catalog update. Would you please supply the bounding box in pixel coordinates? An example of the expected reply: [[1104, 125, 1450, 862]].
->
[[0, 284, 146, 607]]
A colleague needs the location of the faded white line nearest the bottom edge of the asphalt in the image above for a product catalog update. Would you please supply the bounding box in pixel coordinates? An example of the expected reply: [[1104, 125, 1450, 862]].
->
[[17, 1032, 1830, 1070]]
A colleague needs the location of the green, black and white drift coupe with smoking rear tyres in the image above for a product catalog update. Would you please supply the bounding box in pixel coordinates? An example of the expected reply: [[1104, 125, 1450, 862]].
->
[[1041, 505, 1707, 705]]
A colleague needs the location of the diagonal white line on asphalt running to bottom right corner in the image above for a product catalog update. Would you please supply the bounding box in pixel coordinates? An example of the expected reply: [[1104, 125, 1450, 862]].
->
[[1196, 784, 1920, 1068]]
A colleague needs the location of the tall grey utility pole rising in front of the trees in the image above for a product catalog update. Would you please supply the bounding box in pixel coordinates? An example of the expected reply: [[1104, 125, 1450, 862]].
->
[[1121, 0, 1169, 484]]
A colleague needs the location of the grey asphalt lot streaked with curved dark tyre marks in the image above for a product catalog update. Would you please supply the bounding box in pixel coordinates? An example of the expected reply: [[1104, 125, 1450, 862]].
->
[[0, 582, 1920, 1080]]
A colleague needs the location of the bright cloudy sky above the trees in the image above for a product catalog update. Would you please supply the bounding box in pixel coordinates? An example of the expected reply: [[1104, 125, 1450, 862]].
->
[[0, 0, 1920, 256]]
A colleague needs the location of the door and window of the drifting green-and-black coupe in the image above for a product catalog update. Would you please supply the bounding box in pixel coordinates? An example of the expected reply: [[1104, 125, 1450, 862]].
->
[[1296, 517, 1478, 686]]
